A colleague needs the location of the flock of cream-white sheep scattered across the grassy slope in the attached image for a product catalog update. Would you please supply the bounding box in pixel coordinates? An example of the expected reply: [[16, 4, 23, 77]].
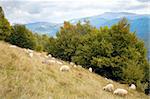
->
[[10, 46, 136, 96]]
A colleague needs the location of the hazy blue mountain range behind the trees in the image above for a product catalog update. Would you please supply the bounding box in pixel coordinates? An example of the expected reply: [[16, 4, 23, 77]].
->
[[25, 12, 150, 57]]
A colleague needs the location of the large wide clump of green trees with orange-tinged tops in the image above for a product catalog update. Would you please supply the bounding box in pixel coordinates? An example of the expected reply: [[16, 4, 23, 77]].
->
[[49, 18, 149, 90]]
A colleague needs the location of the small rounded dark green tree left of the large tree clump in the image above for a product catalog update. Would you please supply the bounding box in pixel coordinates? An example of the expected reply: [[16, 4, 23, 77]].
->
[[9, 24, 36, 49]]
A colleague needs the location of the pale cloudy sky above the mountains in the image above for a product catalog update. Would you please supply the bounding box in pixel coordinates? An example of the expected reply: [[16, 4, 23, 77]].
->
[[0, 0, 150, 24]]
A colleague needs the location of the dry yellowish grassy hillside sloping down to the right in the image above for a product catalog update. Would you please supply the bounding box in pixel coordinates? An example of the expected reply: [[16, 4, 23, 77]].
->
[[0, 42, 149, 99]]
